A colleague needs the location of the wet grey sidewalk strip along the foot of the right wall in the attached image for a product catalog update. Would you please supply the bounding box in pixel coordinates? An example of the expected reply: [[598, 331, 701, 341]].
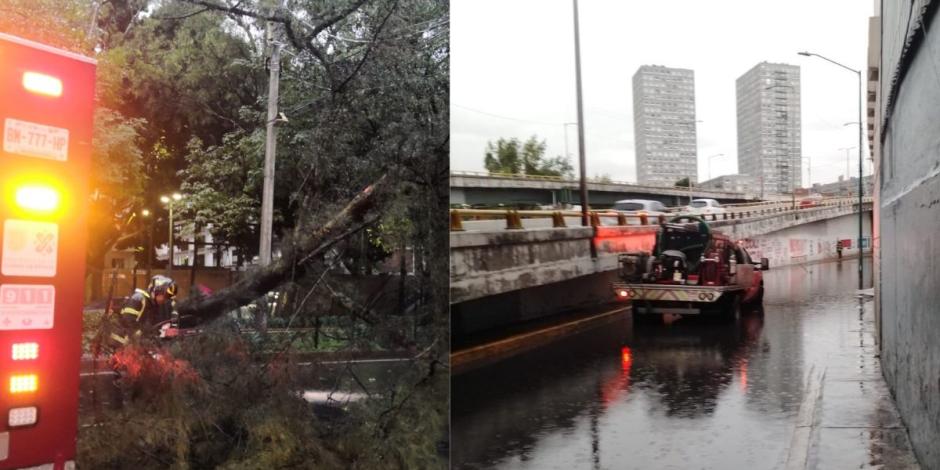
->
[[786, 296, 920, 470]]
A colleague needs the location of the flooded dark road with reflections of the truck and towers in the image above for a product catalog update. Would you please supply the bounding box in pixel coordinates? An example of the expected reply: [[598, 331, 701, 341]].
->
[[451, 259, 880, 469]]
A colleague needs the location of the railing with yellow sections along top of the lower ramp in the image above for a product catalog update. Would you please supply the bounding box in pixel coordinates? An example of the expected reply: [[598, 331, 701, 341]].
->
[[450, 197, 873, 232]]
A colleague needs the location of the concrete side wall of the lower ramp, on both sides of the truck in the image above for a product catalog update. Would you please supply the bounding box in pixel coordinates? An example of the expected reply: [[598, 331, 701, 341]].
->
[[450, 198, 872, 331]]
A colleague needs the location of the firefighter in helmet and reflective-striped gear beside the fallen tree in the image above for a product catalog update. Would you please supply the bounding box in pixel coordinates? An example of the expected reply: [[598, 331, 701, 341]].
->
[[111, 274, 178, 347]]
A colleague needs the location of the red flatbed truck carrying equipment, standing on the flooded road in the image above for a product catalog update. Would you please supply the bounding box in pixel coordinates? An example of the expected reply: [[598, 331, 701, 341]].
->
[[612, 215, 769, 319]]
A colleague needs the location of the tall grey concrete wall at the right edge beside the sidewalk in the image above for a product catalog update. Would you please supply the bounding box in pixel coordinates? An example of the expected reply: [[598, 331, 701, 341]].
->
[[876, 0, 940, 469]]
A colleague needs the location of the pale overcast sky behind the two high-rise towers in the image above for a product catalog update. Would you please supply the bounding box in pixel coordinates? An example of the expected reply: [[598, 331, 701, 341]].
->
[[450, 0, 875, 185]]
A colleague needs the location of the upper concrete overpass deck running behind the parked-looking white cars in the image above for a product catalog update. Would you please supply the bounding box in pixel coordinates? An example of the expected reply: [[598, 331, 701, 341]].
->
[[450, 172, 772, 207]]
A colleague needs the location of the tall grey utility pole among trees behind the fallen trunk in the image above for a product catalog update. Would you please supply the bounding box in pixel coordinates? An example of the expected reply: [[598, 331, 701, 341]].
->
[[258, 0, 283, 266]]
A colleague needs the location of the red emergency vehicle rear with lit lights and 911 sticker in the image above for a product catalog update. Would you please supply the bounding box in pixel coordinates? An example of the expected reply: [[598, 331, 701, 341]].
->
[[0, 33, 95, 470]]
